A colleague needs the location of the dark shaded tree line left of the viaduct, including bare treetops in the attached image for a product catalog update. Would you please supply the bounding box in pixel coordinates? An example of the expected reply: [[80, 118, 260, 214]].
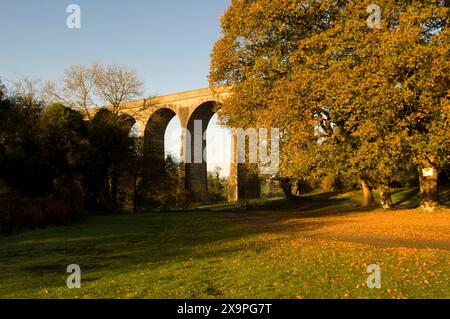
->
[[0, 65, 178, 233]]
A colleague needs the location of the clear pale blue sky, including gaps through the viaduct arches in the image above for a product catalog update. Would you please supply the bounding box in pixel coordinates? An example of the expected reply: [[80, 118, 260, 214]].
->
[[0, 0, 230, 175]]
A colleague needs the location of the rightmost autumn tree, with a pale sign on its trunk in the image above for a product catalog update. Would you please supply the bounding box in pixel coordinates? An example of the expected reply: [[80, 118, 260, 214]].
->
[[386, 1, 450, 210]]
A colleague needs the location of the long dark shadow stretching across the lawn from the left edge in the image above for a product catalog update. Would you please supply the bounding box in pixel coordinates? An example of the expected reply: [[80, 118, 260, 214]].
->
[[0, 190, 446, 295]]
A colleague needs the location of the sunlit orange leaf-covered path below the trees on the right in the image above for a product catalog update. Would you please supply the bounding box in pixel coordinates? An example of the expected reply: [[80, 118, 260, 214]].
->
[[223, 209, 450, 250]]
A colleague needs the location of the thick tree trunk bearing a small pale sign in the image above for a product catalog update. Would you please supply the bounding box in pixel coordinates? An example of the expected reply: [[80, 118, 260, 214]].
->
[[417, 156, 439, 212]]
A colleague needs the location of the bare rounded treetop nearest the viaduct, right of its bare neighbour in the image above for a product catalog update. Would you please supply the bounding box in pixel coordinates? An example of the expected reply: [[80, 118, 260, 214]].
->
[[95, 65, 144, 114]]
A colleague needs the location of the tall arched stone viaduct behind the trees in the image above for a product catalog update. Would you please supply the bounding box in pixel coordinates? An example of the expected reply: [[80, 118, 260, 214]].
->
[[100, 88, 259, 202]]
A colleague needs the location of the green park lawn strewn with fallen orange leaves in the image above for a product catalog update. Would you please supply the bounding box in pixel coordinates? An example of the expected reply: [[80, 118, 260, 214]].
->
[[0, 190, 450, 298]]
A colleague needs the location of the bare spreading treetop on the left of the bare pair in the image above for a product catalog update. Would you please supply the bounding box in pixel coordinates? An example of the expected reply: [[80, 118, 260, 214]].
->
[[44, 63, 100, 119]]
